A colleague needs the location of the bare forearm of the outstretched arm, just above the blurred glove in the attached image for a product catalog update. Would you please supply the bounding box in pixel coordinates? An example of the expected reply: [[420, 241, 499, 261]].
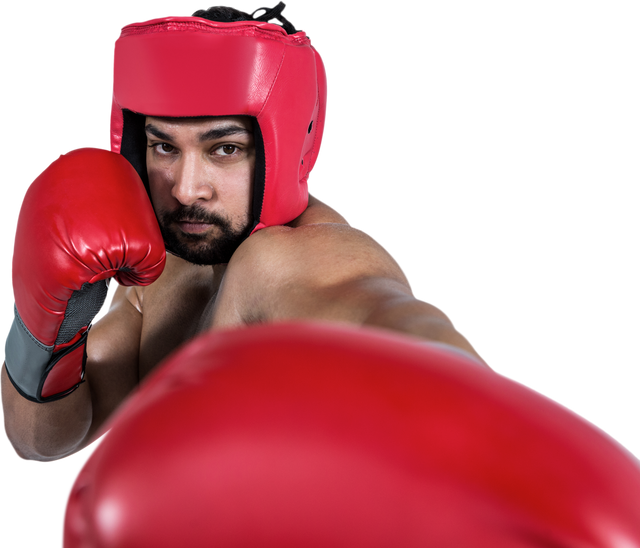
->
[[364, 297, 493, 369]]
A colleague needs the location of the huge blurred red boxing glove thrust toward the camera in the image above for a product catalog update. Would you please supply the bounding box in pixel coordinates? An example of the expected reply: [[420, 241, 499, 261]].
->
[[60, 324, 640, 548]]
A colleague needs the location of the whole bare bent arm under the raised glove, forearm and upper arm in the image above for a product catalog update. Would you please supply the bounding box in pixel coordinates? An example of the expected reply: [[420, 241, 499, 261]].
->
[[0, 286, 142, 462]]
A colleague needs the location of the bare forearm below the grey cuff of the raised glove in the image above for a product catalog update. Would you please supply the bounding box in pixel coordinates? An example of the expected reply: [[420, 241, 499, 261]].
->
[[0, 363, 92, 462]]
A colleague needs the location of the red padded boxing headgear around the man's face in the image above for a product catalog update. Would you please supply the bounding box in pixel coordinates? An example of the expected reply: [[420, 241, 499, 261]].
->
[[108, 13, 329, 234]]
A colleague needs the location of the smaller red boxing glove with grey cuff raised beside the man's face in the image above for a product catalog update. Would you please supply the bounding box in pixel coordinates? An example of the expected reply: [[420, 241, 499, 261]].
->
[[3, 145, 165, 402]]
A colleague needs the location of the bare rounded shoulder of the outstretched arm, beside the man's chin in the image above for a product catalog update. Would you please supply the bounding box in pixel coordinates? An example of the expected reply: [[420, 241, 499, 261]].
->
[[224, 200, 415, 323]]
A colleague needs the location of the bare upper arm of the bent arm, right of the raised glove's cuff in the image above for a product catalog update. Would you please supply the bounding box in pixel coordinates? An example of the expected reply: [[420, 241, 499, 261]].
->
[[75, 285, 142, 448]]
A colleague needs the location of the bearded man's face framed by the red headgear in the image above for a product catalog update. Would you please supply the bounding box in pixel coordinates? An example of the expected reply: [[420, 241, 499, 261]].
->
[[145, 116, 255, 265]]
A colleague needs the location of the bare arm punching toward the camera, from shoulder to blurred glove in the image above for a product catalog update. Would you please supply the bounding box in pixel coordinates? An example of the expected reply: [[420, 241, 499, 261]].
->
[[222, 223, 491, 367]]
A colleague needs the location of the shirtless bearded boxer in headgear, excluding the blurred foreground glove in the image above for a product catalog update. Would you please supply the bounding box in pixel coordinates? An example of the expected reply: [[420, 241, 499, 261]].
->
[[1, 5, 482, 462]]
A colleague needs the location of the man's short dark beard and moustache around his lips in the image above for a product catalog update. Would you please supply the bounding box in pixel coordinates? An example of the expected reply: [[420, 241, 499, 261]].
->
[[156, 207, 253, 266]]
